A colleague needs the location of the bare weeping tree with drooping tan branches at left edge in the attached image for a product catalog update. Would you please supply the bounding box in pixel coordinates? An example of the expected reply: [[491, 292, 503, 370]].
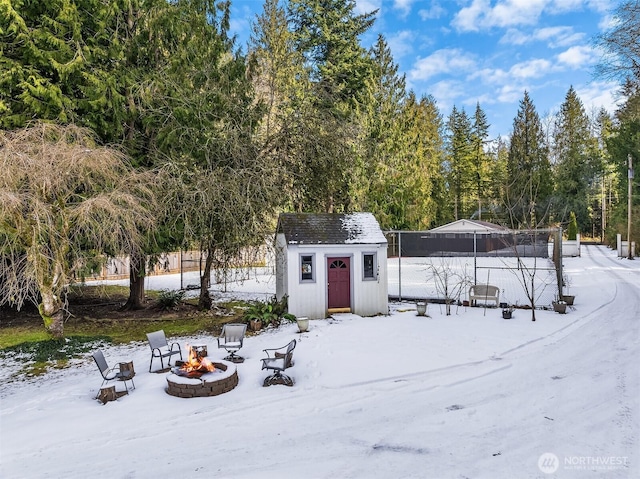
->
[[0, 123, 154, 338]]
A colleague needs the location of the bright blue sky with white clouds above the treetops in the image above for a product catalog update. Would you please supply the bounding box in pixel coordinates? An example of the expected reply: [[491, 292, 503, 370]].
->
[[231, 0, 619, 138]]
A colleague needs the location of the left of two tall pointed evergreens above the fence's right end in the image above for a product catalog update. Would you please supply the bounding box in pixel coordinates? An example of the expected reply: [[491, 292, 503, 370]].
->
[[505, 91, 553, 228]]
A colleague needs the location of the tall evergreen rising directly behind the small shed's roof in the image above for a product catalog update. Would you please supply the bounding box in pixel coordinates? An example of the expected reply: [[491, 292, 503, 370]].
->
[[289, 0, 375, 212]]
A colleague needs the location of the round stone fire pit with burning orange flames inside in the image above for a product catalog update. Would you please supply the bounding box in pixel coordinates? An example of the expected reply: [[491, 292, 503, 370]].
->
[[166, 346, 238, 398]]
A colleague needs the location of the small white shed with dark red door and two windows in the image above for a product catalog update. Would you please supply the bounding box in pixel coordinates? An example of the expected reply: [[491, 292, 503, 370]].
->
[[276, 213, 389, 319]]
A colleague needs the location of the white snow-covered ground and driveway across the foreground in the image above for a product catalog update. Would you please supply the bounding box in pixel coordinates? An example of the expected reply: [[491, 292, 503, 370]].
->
[[0, 246, 640, 479]]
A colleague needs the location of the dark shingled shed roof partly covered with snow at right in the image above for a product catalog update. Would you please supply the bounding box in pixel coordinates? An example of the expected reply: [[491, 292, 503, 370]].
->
[[277, 213, 387, 245]]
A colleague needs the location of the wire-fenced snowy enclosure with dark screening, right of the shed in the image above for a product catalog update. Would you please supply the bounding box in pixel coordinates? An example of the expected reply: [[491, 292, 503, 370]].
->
[[386, 229, 564, 306]]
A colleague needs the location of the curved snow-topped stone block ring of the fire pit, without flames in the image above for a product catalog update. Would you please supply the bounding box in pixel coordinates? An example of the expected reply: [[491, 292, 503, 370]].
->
[[166, 360, 238, 398]]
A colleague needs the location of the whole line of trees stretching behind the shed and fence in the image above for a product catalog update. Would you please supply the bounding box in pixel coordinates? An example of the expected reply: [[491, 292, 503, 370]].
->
[[0, 0, 640, 335]]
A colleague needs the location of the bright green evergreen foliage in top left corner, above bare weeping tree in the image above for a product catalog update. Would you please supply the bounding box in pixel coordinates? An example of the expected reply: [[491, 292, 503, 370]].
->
[[0, 0, 114, 129]]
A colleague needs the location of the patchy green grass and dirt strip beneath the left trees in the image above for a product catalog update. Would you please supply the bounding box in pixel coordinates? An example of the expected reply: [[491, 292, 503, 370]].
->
[[0, 286, 247, 376]]
